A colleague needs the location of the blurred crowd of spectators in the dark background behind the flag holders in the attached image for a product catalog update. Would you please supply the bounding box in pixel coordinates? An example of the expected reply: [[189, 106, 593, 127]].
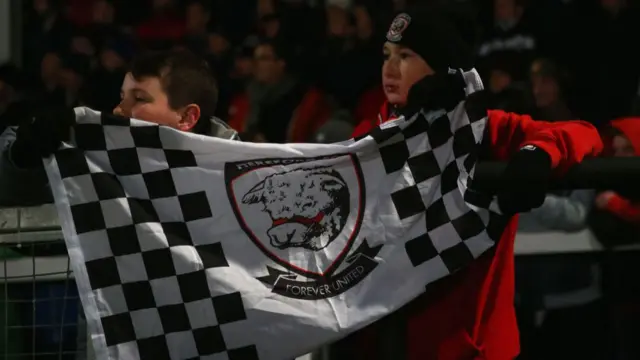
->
[[0, 0, 640, 359]]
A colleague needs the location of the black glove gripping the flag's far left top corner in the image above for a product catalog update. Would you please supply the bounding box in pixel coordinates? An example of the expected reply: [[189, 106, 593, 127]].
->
[[11, 108, 76, 168]]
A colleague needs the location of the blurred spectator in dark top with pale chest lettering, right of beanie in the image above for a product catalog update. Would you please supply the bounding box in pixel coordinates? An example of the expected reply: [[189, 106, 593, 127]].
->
[[478, 0, 537, 81]]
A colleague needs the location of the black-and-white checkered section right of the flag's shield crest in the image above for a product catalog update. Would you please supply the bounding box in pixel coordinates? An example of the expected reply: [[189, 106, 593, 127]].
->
[[350, 95, 508, 273]]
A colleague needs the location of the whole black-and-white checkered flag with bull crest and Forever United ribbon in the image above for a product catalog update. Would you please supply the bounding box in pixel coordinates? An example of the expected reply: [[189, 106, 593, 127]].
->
[[45, 71, 504, 360]]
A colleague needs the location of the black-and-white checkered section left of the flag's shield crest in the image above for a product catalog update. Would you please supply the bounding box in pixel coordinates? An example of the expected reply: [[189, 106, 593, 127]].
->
[[56, 114, 258, 360]]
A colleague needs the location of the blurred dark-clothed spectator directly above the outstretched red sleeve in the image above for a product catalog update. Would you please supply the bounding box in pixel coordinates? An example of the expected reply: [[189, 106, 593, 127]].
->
[[531, 59, 575, 121]]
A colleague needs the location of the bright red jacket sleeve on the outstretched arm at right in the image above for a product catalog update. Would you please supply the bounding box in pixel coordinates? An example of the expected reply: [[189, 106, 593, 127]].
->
[[485, 110, 603, 171]]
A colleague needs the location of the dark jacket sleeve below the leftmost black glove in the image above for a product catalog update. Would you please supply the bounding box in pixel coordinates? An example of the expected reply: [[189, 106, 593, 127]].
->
[[0, 128, 53, 207]]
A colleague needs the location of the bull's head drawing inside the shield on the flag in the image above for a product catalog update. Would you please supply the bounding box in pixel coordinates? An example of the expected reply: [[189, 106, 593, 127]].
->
[[242, 167, 350, 251]]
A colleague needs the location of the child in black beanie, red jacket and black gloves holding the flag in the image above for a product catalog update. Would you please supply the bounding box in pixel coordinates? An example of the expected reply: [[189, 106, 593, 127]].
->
[[330, 6, 602, 360]]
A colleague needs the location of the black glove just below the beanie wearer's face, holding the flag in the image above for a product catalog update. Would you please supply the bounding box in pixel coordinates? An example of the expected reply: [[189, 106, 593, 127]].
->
[[400, 71, 466, 116]]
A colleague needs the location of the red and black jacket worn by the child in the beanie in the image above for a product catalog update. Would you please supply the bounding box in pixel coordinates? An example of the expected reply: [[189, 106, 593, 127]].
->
[[347, 99, 602, 360]]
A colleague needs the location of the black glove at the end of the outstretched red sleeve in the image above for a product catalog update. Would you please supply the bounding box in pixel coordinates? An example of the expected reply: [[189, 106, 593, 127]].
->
[[497, 145, 553, 215]]
